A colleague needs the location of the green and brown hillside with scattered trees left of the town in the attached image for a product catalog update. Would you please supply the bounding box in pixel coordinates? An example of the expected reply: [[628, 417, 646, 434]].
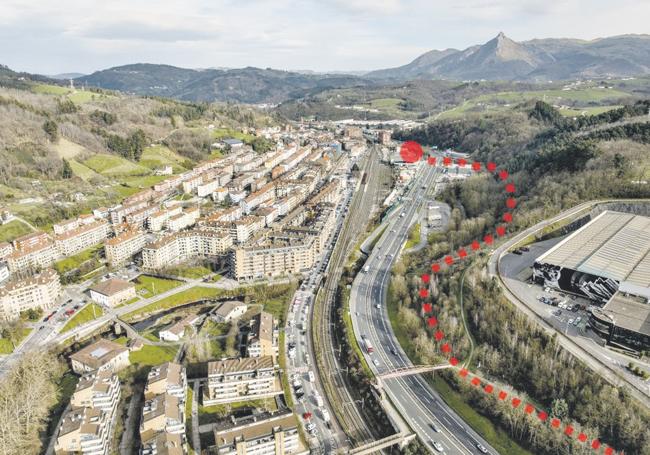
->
[[0, 68, 277, 235]]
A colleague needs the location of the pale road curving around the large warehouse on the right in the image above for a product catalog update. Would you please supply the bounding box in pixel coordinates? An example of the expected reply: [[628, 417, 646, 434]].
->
[[488, 200, 650, 407]]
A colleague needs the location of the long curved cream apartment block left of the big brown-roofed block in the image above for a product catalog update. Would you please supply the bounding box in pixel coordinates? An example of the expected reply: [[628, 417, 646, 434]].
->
[[142, 229, 232, 270]]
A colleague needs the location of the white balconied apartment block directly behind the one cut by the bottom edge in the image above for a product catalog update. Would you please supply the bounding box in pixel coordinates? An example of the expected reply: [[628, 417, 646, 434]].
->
[[203, 356, 282, 406]]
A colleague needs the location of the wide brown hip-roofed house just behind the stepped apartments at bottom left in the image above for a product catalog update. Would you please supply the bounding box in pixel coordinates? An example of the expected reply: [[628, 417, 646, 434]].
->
[[70, 338, 131, 374]]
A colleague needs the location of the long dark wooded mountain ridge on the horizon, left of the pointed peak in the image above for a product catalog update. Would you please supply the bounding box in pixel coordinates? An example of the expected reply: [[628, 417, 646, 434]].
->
[[76, 63, 369, 104]]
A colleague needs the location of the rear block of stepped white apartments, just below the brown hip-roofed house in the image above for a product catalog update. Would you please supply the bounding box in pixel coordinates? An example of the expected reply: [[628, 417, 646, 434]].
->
[[70, 371, 120, 418]]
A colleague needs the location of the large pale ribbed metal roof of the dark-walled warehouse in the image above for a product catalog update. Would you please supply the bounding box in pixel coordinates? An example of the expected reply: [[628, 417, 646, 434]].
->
[[537, 211, 650, 288]]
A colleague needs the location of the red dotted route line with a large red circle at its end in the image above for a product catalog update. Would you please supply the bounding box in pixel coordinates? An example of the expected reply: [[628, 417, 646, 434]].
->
[[401, 143, 614, 455]]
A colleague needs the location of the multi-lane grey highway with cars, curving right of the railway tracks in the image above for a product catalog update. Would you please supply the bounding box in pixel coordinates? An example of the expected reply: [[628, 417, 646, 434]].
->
[[350, 163, 498, 454]]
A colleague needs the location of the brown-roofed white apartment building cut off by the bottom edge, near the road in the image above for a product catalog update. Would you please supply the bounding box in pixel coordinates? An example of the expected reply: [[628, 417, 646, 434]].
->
[[214, 411, 309, 455]]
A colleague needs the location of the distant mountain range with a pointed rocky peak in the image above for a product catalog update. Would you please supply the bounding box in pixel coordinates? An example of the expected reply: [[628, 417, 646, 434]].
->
[[366, 33, 650, 81]]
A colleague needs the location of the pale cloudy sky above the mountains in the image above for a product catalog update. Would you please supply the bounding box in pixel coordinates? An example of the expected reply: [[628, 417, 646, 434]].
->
[[0, 0, 650, 75]]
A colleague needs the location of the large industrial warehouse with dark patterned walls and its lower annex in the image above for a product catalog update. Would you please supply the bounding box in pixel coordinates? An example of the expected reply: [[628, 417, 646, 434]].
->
[[533, 211, 650, 350]]
